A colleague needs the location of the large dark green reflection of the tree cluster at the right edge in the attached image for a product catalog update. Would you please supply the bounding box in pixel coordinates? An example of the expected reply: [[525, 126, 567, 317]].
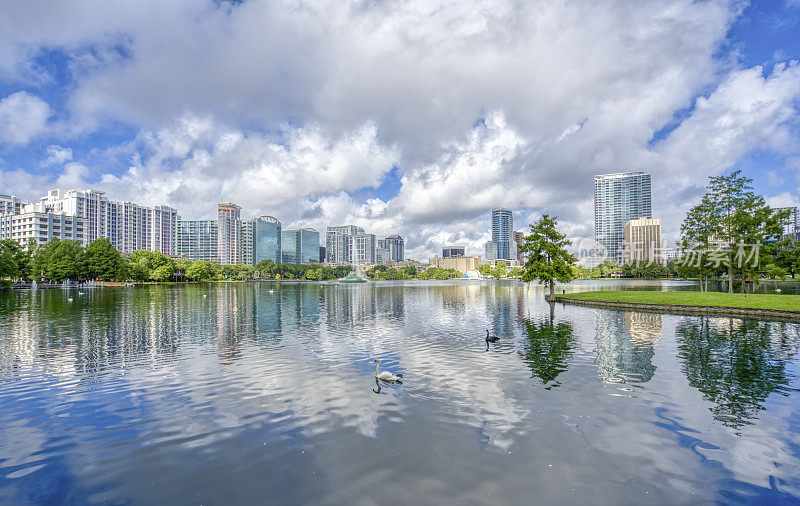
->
[[676, 317, 800, 428]]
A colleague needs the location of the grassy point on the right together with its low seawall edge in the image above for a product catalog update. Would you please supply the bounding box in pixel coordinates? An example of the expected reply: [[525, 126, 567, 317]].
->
[[555, 290, 800, 320]]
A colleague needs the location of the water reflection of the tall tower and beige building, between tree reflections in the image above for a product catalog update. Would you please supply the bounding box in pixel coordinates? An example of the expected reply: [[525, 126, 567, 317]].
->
[[596, 311, 662, 383]]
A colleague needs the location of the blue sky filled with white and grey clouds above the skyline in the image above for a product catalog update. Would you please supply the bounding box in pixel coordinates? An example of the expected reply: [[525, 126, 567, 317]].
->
[[0, 0, 800, 258]]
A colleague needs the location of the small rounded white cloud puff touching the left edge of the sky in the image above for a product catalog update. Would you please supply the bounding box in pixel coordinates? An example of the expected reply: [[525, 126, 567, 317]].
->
[[0, 91, 50, 144]]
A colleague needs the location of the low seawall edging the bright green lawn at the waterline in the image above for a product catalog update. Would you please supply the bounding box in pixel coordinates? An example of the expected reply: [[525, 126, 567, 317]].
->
[[555, 297, 800, 321]]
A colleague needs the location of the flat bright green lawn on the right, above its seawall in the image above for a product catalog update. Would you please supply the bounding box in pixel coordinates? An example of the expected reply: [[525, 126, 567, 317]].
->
[[562, 290, 800, 311]]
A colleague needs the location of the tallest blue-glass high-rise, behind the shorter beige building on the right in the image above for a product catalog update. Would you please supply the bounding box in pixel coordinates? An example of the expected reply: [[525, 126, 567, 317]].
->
[[594, 172, 653, 263]]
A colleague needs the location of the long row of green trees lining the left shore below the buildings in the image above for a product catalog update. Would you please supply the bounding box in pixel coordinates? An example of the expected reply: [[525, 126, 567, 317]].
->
[[0, 238, 351, 284]]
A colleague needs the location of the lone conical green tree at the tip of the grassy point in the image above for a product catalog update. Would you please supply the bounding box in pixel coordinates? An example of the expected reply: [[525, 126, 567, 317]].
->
[[520, 214, 576, 300]]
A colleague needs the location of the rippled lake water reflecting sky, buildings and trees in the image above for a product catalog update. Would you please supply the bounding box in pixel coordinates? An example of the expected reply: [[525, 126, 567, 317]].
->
[[0, 281, 800, 504]]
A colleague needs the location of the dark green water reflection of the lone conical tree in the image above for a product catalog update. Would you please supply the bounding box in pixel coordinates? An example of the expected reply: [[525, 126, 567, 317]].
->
[[520, 319, 575, 390]]
